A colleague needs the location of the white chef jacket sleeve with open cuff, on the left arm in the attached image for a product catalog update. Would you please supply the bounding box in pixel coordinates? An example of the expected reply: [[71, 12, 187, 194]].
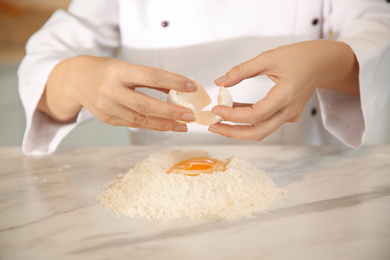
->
[[18, 0, 120, 155]]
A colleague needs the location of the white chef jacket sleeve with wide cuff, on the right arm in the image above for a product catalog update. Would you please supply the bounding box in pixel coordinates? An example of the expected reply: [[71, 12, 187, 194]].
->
[[317, 0, 390, 148]]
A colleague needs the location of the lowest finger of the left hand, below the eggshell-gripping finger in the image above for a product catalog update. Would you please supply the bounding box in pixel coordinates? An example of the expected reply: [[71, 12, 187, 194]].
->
[[99, 105, 188, 132]]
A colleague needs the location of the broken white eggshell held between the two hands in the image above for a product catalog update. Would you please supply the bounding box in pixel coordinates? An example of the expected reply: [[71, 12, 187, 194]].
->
[[167, 80, 233, 126]]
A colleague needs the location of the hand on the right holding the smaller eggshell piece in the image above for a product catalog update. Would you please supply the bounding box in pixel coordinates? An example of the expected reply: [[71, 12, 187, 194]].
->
[[209, 40, 359, 141]]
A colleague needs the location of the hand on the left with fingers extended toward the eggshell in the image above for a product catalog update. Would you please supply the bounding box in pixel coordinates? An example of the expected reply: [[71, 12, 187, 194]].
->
[[37, 56, 197, 132]]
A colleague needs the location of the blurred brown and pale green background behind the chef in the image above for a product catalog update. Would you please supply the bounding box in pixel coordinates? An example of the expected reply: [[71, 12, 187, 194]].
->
[[0, 0, 390, 146]]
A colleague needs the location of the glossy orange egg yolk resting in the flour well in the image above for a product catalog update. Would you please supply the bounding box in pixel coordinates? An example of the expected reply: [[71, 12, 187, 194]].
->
[[167, 157, 227, 176]]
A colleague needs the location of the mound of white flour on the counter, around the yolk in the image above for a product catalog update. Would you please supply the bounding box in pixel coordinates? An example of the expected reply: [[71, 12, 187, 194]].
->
[[97, 150, 284, 221]]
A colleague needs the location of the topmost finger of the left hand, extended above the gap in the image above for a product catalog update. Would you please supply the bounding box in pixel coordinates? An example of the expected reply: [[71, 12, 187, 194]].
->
[[119, 63, 197, 92]]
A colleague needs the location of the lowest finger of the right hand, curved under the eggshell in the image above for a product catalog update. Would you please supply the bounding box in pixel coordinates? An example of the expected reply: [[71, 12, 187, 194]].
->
[[209, 108, 288, 142]]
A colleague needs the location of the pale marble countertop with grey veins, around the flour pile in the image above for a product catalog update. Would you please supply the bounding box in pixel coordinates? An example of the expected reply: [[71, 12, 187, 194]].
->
[[0, 145, 390, 260]]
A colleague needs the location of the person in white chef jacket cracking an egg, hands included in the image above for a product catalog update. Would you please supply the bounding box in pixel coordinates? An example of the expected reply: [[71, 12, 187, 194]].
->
[[18, 0, 390, 155]]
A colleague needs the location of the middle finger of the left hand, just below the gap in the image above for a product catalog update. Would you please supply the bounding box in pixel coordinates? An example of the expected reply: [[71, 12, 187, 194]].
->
[[115, 88, 196, 122]]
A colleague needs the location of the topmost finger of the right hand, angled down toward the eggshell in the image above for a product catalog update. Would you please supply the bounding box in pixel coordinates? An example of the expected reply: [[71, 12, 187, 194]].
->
[[214, 54, 266, 87]]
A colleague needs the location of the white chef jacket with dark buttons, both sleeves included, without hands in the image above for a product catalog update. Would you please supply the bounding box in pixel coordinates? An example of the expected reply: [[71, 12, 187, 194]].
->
[[18, 0, 390, 155]]
